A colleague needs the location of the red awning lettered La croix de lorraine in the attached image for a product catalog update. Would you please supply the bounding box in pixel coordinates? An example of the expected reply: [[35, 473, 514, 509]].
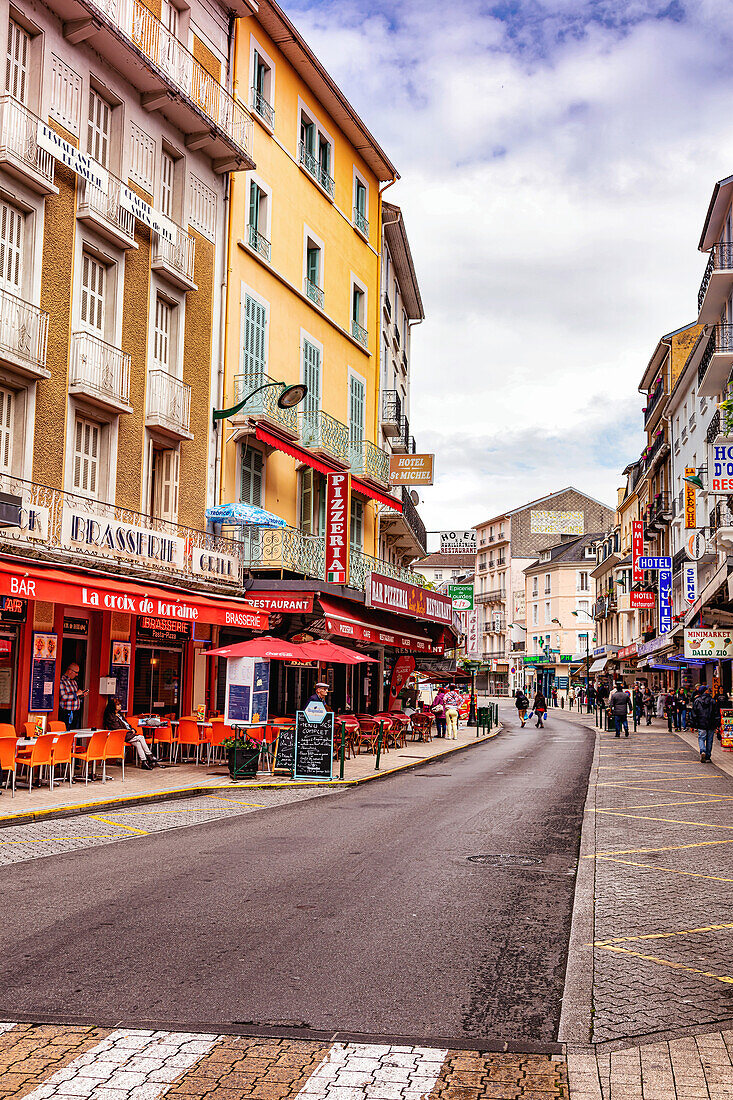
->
[[0, 560, 270, 630]]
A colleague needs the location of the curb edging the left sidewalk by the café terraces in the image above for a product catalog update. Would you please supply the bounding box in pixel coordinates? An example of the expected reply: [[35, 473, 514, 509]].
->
[[0, 722, 503, 828]]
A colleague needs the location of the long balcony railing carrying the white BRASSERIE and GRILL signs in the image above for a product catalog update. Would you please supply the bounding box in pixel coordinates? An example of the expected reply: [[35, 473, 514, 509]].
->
[[0, 474, 243, 593]]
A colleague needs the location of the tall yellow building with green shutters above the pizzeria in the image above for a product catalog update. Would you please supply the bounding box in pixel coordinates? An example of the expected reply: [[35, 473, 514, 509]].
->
[[220, 2, 397, 585]]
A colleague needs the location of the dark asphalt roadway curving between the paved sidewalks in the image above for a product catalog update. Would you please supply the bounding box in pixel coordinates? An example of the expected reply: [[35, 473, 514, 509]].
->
[[0, 705, 593, 1041]]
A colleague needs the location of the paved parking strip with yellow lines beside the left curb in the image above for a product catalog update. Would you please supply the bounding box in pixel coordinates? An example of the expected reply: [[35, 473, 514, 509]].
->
[[0, 787, 336, 866]]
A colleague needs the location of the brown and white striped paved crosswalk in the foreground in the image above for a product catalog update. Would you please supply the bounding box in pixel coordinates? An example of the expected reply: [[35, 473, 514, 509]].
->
[[0, 1024, 568, 1100]]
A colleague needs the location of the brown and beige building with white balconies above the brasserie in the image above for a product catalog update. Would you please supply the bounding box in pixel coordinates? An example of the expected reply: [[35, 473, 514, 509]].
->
[[0, 0, 266, 724]]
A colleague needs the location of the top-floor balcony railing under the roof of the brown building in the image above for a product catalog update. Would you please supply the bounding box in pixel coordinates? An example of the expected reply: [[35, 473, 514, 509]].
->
[[93, 0, 253, 161]]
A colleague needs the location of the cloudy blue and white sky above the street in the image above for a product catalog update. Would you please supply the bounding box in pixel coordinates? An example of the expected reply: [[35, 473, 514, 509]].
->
[[285, 0, 733, 528]]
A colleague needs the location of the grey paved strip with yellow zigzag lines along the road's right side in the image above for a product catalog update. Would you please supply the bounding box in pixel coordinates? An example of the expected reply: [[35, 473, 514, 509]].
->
[[587, 727, 733, 1043]]
